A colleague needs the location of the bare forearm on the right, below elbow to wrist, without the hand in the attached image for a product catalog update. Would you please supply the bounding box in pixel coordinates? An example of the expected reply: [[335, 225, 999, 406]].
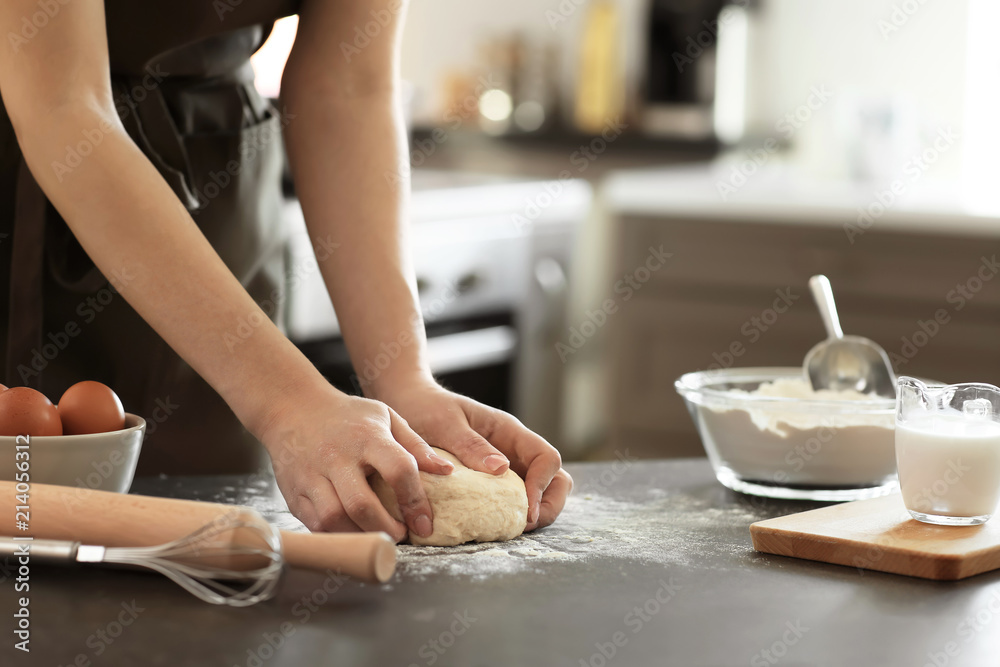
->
[[283, 88, 431, 397]]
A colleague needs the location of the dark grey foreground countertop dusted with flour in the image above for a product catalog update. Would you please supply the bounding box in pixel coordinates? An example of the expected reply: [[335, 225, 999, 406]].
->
[[2, 458, 1000, 667]]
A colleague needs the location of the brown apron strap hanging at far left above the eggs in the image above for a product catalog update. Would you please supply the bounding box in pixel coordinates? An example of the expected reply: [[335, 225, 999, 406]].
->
[[7, 157, 46, 389]]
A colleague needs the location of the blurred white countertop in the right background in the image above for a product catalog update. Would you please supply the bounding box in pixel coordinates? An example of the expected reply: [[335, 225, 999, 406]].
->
[[599, 159, 1000, 239]]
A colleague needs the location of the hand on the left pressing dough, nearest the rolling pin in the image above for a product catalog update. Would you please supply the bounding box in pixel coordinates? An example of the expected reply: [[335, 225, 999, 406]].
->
[[260, 384, 454, 542]]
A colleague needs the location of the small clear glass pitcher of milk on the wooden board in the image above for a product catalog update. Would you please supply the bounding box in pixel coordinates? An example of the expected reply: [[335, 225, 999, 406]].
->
[[896, 376, 1000, 526]]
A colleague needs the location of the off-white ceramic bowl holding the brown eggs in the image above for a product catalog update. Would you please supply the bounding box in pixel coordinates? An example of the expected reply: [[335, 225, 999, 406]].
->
[[0, 414, 146, 493]]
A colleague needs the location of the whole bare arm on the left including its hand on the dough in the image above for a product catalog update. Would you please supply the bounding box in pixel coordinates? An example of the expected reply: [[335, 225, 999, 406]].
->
[[0, 0, 450, 538]]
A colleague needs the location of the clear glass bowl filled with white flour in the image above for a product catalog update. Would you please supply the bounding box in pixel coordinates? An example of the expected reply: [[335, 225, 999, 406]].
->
[[674, 367, 898, 501]]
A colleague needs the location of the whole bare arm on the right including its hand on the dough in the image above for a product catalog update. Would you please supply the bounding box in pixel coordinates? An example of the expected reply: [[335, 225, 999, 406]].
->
[[282, 0, 572, 530]]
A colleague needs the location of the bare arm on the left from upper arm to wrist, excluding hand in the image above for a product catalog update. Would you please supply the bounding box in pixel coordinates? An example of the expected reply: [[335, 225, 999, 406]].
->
[[0, 0, 322, 429]]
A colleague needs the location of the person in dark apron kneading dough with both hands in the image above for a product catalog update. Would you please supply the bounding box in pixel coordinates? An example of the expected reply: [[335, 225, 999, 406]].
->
[[0, 0, 573, 544]]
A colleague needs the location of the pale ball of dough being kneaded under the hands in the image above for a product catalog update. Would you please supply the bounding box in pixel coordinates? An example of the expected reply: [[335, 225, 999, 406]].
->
[[371, 447, 528, 547]]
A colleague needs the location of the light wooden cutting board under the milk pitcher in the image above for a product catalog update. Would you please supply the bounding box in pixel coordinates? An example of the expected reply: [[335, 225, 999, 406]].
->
[[750, 493, 1000, 580]]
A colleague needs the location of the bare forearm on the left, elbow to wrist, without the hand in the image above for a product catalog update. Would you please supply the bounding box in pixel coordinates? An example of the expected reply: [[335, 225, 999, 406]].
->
[[19, 106, 322, 432]]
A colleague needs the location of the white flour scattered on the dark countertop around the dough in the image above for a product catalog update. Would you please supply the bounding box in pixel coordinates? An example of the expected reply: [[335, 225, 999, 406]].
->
[[168, 472, 764, 580]]
